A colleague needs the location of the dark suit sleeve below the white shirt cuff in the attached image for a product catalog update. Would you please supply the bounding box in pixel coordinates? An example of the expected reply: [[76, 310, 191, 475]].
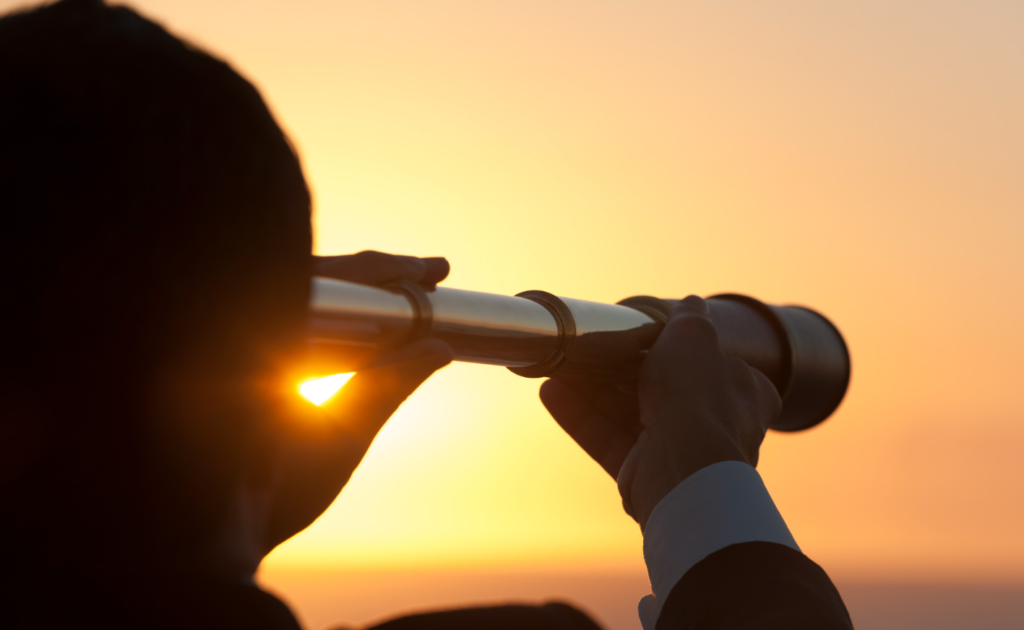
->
[[655, 542, 853, 630]]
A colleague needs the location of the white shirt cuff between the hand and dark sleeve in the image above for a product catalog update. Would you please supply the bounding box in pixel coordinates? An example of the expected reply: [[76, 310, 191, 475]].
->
[[639, 461, 800, 630]]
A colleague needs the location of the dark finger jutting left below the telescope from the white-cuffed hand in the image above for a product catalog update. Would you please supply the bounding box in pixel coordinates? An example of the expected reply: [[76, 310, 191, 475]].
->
[[541, 379, 636, 478]]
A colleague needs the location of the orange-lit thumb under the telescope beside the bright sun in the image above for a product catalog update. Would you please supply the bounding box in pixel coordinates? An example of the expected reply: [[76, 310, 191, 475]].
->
[[321, 339, 453, 447]]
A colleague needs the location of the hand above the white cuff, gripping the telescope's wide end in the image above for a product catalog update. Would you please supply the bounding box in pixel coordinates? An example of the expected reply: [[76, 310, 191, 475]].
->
[[541, 296, 781, 528]]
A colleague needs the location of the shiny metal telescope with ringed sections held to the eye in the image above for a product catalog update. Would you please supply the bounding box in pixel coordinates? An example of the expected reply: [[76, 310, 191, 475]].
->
[[308, 278, 850, 431]]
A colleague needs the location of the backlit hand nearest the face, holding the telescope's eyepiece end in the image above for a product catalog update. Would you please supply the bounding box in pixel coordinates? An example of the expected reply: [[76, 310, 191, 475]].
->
[[264, 252, 452, 552]]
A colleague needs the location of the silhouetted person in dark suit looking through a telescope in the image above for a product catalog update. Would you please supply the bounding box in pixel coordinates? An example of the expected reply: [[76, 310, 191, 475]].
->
[[0, 0, 849, 630]]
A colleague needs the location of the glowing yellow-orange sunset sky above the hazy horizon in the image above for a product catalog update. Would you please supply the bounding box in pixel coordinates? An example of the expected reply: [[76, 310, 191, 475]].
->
[[9, 0, 1024, 581]]
